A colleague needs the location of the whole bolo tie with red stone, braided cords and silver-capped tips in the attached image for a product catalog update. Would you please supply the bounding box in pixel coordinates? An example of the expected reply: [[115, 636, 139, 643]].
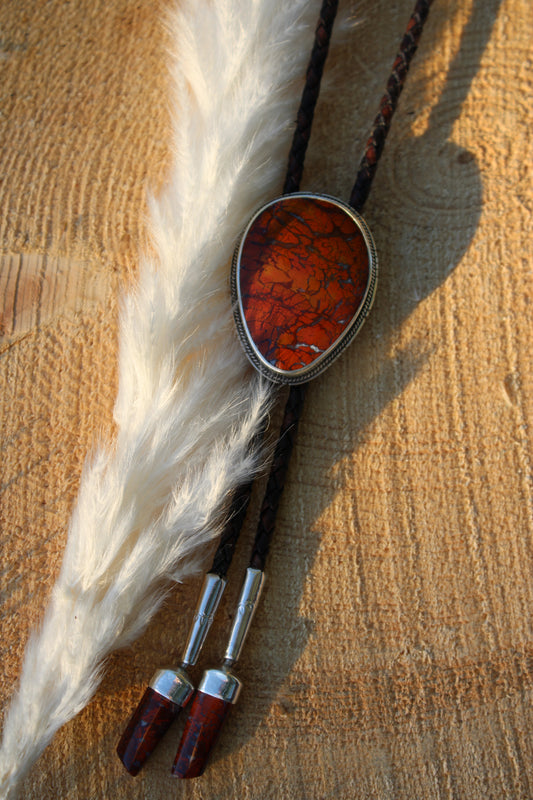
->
[[117, 0, 432, 778]]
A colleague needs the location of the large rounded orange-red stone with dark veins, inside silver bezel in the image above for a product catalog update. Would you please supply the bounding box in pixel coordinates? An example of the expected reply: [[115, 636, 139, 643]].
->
[[233, 195, 372, 382]]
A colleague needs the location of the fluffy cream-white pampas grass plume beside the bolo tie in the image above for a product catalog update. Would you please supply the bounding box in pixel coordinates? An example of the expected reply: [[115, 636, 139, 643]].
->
[[0, 0, 324, 798]]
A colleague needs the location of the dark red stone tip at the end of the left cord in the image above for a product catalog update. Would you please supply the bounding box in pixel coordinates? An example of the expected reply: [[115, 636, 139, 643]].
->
[[117, 687, 180, 775]]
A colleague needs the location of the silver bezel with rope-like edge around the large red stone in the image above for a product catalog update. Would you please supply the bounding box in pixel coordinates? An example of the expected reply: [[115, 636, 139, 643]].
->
[[231, 192, 378, 385]]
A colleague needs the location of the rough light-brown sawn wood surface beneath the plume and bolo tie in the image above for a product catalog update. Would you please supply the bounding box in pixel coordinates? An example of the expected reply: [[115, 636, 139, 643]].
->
[[0, 0, 533, 800]]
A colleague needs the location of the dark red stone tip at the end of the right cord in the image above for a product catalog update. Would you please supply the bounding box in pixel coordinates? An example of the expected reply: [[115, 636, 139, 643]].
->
[[172, 692, 232, 778]]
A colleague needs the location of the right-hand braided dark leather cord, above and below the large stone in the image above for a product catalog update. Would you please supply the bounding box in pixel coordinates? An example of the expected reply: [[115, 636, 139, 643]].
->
[[250, 0, 433, 570]]
